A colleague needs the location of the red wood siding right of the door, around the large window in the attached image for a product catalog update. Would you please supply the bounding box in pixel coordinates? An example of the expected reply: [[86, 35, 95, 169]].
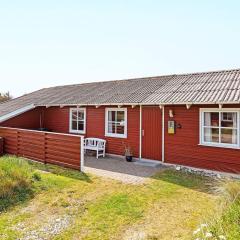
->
[[165, 105, 240, 173]]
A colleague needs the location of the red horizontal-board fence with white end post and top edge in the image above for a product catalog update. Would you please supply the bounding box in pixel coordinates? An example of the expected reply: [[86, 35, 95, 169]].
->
[[0, 127, 84, 170]]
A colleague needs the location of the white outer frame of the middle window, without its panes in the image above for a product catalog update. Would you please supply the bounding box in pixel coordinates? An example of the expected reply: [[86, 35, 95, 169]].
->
[[105, 108, 127, 138]]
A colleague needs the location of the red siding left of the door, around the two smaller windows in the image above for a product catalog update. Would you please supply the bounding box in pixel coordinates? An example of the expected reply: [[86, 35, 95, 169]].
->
[[44, 107, 139, 157]]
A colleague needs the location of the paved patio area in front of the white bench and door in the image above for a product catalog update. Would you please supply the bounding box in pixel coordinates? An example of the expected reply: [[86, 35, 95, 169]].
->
[[84, 156, 165, 184]]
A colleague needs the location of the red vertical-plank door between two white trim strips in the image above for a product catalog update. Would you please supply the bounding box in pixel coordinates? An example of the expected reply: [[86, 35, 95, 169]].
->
[[142, 106, 162, 160]]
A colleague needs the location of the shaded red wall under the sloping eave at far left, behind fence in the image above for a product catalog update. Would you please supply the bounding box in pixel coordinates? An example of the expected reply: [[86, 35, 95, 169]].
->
[[0, 108, 42, 129]]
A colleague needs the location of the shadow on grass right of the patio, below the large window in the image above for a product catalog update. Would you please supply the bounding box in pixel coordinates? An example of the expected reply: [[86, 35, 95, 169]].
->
[[152, 169, 216, 194]]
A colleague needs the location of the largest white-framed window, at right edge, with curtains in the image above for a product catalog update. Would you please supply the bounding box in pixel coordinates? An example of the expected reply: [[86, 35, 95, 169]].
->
[[200, 109, 240, 148]]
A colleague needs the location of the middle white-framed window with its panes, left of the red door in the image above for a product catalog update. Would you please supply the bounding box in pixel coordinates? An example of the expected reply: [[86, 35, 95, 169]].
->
[[105, 108, 127, 138]]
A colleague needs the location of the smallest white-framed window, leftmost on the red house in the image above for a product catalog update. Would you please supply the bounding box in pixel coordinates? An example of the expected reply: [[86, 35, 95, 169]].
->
[[69, 108, 86, 134]]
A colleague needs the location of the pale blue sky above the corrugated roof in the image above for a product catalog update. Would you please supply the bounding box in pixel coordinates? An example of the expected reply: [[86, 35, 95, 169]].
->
[[0, 0, 240, 97]]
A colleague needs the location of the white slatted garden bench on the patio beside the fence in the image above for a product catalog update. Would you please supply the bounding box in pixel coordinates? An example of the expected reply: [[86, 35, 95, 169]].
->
[[84, 138, 106, 159]]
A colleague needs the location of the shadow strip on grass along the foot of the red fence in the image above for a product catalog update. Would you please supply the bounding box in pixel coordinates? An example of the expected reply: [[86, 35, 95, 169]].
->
[[29, 161, 92, 183]]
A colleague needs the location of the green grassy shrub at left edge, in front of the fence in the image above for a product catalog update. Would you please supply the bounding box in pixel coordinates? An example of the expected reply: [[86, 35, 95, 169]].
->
[[0, 157, 33, 211]]
